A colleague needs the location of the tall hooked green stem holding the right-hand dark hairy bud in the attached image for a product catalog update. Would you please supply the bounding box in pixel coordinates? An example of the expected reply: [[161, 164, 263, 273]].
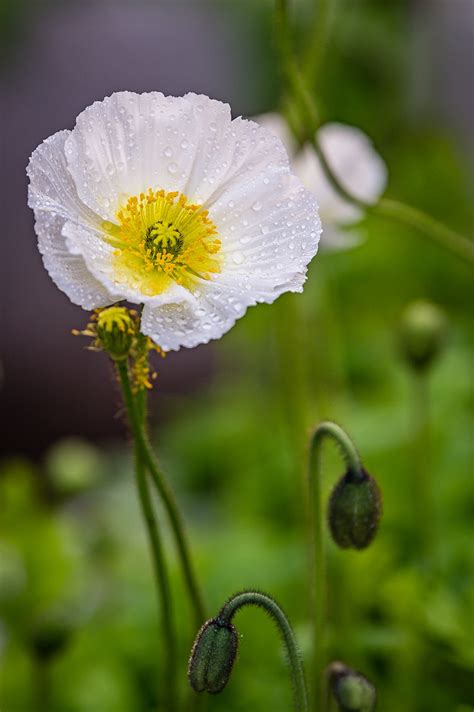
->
[[307, 421, 362, 711]]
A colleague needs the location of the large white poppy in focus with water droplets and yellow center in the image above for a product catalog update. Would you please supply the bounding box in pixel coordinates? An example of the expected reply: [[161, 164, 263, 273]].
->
[[28, 92, 321, 350]]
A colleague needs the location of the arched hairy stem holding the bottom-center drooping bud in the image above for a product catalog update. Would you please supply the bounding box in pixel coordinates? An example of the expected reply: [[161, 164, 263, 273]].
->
[[217, 591, 308, 712]]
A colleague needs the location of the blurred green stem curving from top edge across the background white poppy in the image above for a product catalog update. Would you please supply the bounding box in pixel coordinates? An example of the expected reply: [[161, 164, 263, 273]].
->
[[275, 0, 474, 264]]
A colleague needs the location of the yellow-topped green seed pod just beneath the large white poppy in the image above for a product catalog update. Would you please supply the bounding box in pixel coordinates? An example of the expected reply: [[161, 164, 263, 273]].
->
[[96, 307, 136, 361]]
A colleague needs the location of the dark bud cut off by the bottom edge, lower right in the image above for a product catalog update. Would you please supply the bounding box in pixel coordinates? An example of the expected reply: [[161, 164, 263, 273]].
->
[[328, 662, 377, 712]]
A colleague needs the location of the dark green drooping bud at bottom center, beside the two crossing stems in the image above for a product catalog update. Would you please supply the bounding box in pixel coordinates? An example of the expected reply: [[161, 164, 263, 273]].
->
[[188, 618, 238, 694]]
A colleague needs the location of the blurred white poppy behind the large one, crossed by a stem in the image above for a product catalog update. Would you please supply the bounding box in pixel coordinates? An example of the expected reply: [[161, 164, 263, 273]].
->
[[255, 113, 387, 249]]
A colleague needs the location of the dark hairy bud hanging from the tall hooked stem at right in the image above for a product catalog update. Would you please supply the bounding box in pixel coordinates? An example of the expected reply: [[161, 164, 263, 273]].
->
[[328, 469, 382, 549]]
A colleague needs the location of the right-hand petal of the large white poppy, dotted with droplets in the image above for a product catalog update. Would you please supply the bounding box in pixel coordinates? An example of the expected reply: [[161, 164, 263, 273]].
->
[[209, 169, 321, 294]]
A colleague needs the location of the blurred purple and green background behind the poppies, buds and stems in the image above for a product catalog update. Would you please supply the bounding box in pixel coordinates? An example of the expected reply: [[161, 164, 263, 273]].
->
[[0, 0, 474, 712]]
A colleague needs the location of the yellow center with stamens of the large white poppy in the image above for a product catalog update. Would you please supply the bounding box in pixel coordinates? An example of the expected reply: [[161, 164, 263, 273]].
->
[[102, 188, 221, 296]]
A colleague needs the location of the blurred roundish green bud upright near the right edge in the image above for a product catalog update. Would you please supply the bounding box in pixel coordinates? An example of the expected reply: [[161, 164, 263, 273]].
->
[[400, 301, 447, 371]]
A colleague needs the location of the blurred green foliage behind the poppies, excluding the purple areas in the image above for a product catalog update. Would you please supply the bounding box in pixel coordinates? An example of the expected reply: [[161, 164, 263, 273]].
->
[[0, 2, 474, 712]]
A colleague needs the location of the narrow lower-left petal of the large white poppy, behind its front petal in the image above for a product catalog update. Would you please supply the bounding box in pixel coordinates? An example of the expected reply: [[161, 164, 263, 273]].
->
[[35, 210, 114, 309]]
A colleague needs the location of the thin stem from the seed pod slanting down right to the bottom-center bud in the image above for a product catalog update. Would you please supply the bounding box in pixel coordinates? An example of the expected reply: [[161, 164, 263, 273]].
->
[[117, 362, 206, 626]]
